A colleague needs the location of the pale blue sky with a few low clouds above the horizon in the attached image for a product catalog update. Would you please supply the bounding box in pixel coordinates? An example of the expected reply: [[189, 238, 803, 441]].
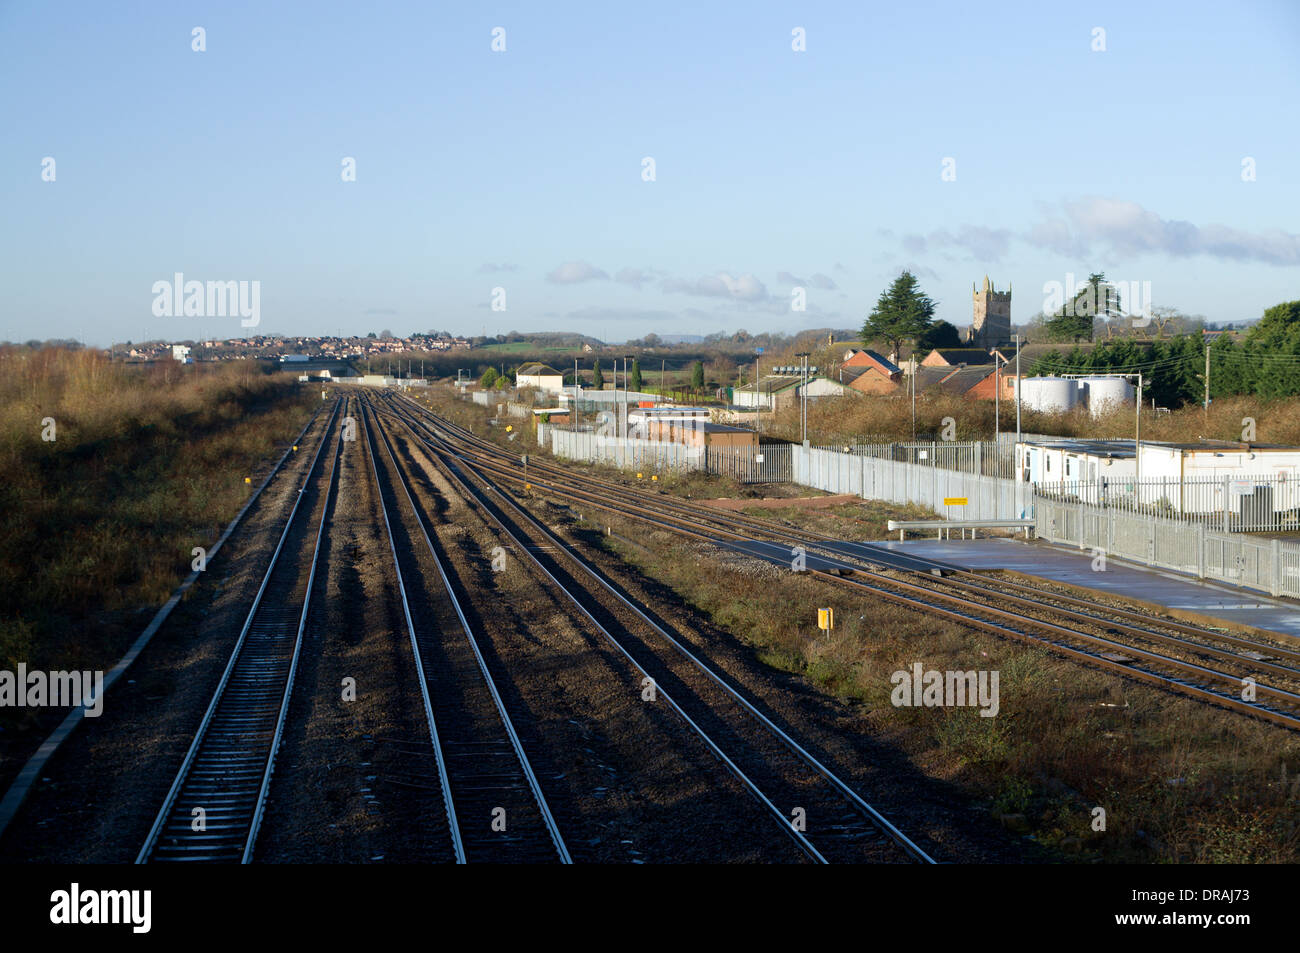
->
[[0, 0, 1300, 346]]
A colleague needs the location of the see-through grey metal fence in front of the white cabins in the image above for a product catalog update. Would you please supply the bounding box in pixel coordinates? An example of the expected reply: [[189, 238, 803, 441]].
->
[[1035, 473, 1300, 533]]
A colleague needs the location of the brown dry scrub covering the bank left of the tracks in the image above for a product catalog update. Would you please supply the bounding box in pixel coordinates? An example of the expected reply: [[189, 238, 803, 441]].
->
[[0, 348, 319, 668]]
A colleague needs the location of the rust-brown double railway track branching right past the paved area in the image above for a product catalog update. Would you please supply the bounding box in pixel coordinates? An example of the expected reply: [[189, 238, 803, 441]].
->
[[389, 398, 1300, 728]]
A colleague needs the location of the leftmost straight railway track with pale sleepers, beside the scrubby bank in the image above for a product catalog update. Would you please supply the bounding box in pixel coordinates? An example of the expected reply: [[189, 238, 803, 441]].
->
[[137, 399, 346, 863]]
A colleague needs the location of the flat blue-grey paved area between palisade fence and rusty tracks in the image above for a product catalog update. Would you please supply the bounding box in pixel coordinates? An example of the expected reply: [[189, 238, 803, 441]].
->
[[836, 538, 1300, 640]]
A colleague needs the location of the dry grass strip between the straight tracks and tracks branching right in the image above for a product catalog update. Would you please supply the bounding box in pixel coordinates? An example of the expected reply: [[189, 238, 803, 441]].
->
[[592, 514, 1300, 863]]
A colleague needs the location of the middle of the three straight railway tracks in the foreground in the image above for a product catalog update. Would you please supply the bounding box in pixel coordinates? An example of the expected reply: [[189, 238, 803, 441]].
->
[[363, 408, 572, 863]]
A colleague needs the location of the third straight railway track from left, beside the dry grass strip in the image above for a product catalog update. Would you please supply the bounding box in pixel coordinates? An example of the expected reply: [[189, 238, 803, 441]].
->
[[371, 390, 933, 863]]
